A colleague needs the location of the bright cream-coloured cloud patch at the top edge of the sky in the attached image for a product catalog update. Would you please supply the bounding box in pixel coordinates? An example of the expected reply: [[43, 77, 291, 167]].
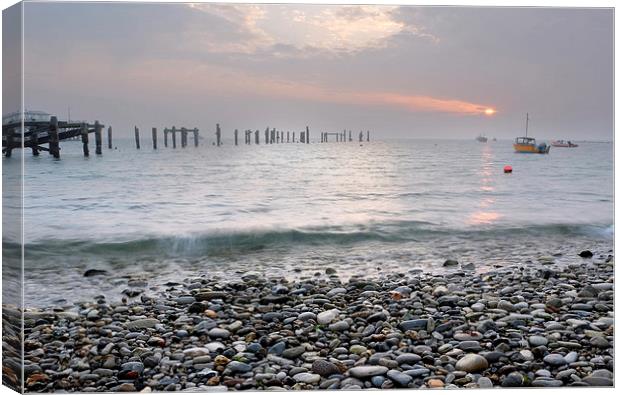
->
[[188, 3, 438, 56]]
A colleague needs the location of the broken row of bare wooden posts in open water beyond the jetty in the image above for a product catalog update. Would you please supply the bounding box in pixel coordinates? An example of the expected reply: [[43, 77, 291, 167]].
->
[[131, 123, 370, 149]]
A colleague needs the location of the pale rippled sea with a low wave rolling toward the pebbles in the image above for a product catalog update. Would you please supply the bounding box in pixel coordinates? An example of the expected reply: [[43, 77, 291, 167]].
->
[[3, 138, 613, 304]]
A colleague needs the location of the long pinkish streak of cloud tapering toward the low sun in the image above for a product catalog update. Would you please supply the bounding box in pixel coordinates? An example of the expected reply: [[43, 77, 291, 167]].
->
[[28, 50, 492, 115]]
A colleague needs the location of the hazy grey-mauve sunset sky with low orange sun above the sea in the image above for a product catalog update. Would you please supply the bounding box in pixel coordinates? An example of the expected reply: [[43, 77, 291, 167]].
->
[[9, 3, 613, 140]]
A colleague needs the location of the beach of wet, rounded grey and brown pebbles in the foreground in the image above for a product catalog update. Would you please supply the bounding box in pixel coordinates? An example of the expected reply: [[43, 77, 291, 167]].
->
[[3, 251, 614, 392]]
